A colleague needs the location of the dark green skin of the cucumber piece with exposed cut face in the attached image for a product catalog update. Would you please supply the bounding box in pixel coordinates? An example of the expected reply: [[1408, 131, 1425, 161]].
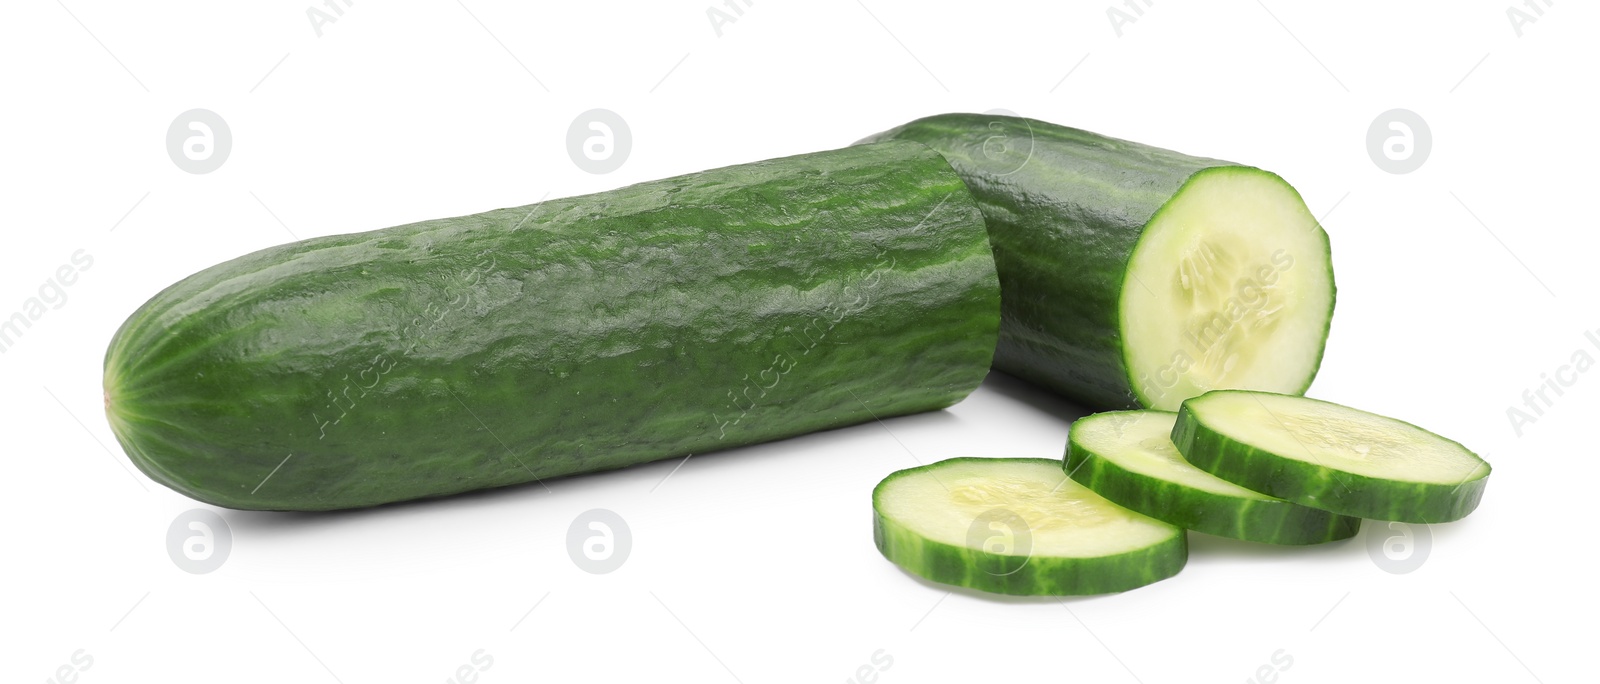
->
[[861, 113, 1333, 409]]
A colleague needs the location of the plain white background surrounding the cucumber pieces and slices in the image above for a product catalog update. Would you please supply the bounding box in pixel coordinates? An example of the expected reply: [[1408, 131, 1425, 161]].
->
[[0, 0, 1600, 684]]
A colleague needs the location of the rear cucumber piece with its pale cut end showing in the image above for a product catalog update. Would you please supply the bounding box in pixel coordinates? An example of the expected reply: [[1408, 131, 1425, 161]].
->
[[862, 113, 1334, 411]]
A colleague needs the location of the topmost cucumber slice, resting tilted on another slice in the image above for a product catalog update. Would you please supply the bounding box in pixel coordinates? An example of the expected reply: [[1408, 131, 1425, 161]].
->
[[1173, 390, 1490, 523]]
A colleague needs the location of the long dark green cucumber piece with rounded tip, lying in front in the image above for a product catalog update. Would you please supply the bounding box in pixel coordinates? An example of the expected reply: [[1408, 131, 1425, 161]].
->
[[106, 142, 1000, 510]]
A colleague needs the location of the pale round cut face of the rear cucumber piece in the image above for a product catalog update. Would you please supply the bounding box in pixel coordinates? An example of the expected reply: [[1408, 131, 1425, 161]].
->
[[1118, 166, 1334, 411]]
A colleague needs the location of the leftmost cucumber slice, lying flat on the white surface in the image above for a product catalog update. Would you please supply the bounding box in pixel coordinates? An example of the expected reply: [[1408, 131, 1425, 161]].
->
[[872, 459, 1189, 596]]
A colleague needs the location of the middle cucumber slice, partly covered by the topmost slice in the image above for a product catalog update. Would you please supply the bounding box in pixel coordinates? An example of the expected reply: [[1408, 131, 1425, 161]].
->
[[1066, 411, 1362, 545]]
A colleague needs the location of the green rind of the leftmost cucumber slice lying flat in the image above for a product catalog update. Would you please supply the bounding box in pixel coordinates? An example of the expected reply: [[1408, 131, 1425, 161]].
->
[[872, 459, 1189, 596]]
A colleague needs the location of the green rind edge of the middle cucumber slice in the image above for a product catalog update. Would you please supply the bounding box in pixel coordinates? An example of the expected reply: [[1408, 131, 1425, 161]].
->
[[1064, 414, 1362, 545]]
